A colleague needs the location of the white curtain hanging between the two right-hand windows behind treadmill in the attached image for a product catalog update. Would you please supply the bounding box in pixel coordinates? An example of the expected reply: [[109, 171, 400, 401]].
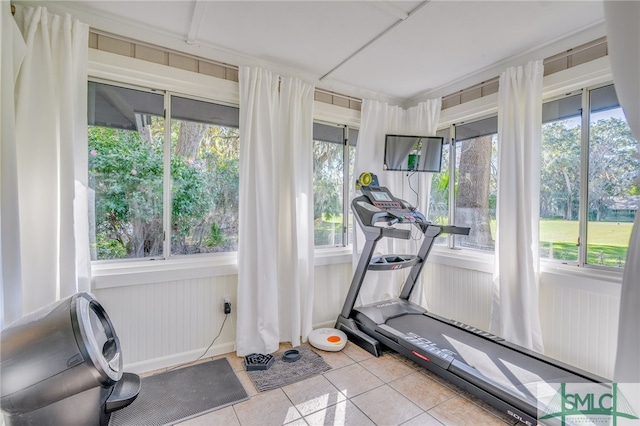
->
[[491, 61, 544, 352]]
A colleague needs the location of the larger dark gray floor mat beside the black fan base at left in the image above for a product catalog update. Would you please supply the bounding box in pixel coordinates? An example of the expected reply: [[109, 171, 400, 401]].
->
[[109, 358, 249, 426]]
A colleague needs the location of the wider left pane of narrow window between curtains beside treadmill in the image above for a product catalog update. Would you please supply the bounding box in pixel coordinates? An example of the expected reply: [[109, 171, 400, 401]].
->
[[313, 138, 344, 246]]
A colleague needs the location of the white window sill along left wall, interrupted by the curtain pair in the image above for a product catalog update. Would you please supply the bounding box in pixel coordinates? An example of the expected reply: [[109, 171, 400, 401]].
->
[[91, 247, 352, 289]]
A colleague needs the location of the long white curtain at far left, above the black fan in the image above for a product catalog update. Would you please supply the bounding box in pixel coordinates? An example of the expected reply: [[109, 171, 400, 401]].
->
[[2, 2, 90, 322]]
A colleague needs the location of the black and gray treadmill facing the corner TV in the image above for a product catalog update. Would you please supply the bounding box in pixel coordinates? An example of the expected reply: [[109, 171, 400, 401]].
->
[[335, 175, 609, 425]]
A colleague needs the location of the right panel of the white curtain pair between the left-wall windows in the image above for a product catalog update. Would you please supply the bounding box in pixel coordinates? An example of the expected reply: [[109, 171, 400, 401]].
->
[[276, 77, 315, 346]]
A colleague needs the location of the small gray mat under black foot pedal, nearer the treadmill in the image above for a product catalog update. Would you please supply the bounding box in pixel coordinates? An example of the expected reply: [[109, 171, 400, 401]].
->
[[247, 346, 331, 392]]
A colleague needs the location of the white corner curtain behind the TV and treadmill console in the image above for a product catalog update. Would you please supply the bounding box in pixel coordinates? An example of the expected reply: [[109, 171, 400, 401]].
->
[[349, 98, 442, 307]]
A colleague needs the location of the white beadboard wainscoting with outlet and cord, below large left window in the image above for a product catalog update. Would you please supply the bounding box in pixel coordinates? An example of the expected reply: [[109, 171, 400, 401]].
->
[[93, 275, 238, 373]]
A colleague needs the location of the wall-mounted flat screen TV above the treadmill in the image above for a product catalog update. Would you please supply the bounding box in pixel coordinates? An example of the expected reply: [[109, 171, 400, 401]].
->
[[384, 135, 443, 173]]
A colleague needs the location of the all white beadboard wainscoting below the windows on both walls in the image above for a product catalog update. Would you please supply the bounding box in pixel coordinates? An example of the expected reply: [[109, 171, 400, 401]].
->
[[93, 254, 620, 378]]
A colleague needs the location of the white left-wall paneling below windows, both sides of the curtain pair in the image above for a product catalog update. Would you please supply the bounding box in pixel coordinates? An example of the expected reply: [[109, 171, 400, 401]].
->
[[92, 256, 351, 373]]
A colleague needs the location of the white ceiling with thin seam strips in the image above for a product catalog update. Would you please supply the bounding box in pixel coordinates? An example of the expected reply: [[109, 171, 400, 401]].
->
[[32, 0, 604, 102]]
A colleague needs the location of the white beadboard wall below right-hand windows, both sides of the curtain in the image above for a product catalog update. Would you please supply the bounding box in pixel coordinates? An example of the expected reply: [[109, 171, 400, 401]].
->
[[424, 252, 621, 378]]
